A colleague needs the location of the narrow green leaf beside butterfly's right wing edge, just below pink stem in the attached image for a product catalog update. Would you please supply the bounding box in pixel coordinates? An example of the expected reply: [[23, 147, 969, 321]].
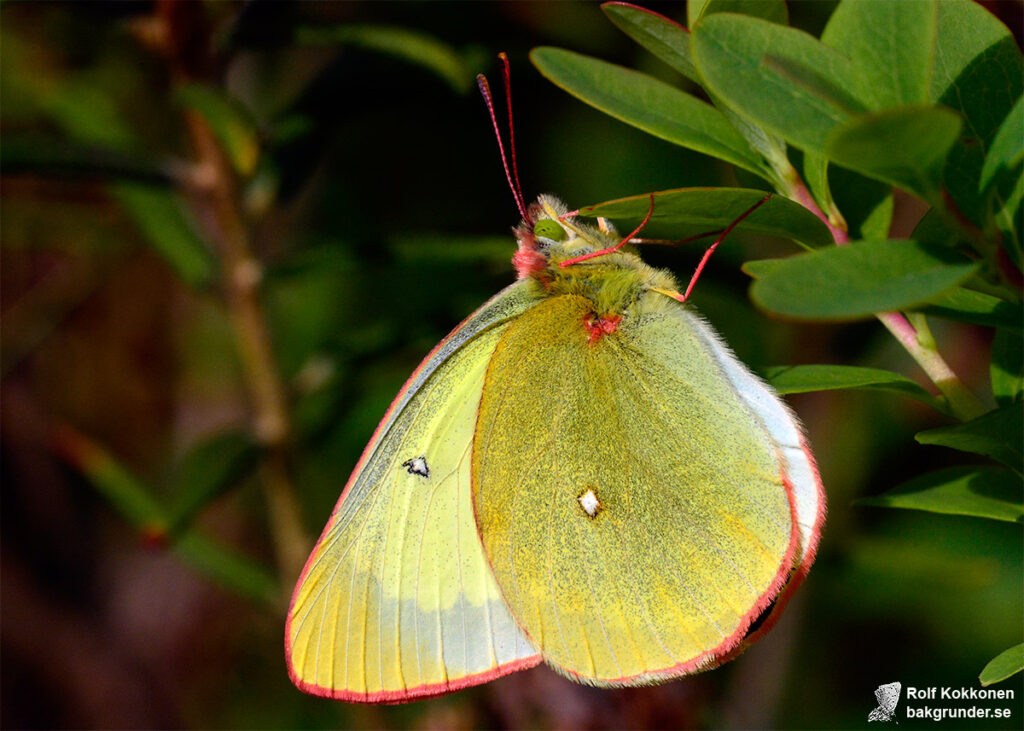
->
[[764, 366, 947, 413]]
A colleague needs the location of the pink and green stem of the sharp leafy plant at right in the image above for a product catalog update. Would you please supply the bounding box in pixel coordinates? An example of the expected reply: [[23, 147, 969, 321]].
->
[[793, 173, 986, 421]]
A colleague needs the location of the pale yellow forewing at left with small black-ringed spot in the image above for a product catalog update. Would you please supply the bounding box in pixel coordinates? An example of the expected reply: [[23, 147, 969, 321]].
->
[[286, 284, 540, 702]]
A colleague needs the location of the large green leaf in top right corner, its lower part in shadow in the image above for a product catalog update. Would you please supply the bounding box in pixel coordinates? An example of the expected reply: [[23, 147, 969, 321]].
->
[[931, 0, 1024, 225]]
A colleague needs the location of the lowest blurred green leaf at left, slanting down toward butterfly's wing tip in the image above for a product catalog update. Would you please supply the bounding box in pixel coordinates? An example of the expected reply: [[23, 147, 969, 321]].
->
[[171, 532, 281, 604]]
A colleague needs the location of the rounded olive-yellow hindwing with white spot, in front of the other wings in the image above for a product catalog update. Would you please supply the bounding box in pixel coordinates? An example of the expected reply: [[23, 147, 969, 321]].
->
[[473, 295, 801, 685]]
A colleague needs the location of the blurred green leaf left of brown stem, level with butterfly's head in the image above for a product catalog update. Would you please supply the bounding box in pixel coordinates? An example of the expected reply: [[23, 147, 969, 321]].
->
[[111, 182, 217, 289]]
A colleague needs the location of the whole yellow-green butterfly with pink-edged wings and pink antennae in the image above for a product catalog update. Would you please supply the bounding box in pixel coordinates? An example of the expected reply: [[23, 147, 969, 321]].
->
[[285, 52, 824, 702]]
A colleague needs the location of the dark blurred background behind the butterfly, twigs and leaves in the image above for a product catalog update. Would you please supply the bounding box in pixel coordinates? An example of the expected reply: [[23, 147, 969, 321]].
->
[[0, 2, 1024, 728]]
